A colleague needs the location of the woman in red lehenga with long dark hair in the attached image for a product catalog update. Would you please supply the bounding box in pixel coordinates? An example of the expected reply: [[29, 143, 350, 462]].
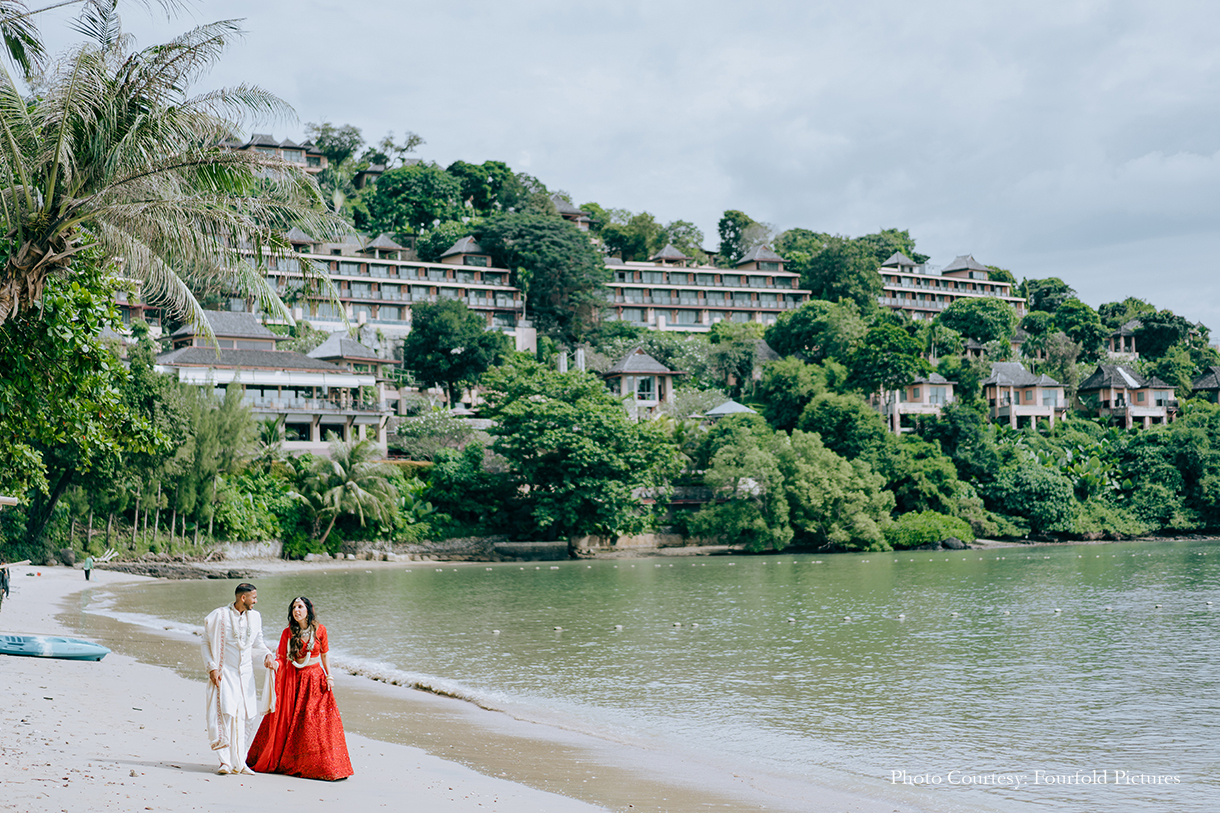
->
[[245, 596, 353, 780]]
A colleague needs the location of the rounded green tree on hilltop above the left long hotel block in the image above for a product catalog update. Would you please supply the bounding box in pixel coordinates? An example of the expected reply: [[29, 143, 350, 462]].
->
[[365, 164, 465, 234]]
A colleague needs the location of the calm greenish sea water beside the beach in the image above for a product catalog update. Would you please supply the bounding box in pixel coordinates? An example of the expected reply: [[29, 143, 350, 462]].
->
[[92, 542, 1220, 813]]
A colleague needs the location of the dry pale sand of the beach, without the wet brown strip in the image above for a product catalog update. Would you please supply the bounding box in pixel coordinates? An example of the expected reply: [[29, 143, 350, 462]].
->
[[0, 568, 605, 813]]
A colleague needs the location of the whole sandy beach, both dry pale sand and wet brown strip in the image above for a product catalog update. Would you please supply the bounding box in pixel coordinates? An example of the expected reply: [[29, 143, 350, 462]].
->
[[0, 562, 932, 813]]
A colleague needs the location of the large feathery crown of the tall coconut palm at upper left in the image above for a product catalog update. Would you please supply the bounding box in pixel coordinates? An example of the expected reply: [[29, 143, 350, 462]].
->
[[0, 0, 343, 331]]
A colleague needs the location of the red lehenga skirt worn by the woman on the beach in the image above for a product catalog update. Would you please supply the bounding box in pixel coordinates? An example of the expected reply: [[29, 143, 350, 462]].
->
[[245, 660, 353, 780]]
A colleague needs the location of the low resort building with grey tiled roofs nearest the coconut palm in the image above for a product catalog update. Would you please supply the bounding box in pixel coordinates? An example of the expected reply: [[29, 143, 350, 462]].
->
[[156, 311, 393, 454]]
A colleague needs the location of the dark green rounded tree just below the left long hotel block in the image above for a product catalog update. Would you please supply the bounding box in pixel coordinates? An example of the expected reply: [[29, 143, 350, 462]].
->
[[403, 299, 512, 404]]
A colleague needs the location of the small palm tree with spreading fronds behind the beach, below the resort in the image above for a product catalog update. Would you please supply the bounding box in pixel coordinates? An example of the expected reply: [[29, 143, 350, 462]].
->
[[298, 441, 398, 546]]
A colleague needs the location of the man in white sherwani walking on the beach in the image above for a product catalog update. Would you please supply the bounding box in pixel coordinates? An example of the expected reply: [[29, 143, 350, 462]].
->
[[201, 582, 277, 774]]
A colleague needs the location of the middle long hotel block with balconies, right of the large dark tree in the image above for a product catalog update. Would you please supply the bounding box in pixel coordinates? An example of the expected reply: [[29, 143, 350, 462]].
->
[[606, 245, 810, 332]]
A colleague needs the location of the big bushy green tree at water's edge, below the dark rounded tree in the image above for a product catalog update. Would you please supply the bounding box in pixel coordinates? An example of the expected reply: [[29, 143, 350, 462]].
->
[[483, 358, 677, 538]]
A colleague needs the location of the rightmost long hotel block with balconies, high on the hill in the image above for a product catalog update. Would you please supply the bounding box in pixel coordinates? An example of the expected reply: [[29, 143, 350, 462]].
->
[[877, 251, 1026, 319]]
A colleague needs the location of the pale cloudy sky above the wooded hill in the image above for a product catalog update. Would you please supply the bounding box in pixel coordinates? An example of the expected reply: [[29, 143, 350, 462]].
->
[[48, 0, 1220, 328]]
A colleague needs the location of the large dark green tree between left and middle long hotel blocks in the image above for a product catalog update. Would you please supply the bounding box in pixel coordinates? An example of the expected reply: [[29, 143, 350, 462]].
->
[[478, 214, 610, 344]]
